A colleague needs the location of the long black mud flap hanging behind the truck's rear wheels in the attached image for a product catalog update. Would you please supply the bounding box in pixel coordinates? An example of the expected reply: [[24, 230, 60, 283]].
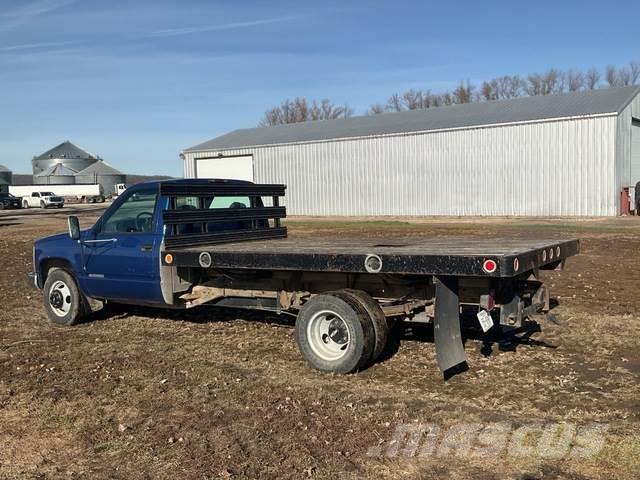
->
[[433, 277, 468, 377]]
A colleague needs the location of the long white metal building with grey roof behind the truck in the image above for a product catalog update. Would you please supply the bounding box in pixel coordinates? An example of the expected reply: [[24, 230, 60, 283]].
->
[[182, 87, 640, 216]]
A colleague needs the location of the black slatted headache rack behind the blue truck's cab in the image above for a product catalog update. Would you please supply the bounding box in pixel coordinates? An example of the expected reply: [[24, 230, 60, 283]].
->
[[160, 181, 287, 248]]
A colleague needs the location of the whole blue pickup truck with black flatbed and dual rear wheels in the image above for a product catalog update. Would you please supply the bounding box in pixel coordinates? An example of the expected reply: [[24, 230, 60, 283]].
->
[[31, 179, 579, 373]]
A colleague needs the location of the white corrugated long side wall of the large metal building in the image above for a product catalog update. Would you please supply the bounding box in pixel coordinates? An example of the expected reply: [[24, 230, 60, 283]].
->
[[185, 116, 619, 216]]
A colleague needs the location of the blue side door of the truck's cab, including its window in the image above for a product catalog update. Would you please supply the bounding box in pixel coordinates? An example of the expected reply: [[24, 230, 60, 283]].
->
[[83, 187, 162, 304]]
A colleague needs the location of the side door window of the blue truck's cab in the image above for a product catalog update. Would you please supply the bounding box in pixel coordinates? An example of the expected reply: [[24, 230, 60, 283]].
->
[[100, 188, 158, 233]]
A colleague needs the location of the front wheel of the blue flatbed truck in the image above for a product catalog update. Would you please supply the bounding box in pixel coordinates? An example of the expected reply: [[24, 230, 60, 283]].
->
[[43, 268, 89, 326]]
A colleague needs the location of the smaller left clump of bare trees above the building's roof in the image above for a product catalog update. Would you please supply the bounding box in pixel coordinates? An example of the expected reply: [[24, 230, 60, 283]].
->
[[260, 97, 353, 127]]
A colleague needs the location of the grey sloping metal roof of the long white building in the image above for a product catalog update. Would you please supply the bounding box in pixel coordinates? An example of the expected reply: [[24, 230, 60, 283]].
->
[[185, 86, 640, 152]]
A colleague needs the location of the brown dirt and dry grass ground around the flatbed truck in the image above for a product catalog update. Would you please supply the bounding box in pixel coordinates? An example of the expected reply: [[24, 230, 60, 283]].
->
[[0, 207, 640, 480]]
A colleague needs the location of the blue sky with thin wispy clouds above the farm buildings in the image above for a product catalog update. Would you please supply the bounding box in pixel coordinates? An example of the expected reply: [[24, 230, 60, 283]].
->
[[0, 0, 640, 176]]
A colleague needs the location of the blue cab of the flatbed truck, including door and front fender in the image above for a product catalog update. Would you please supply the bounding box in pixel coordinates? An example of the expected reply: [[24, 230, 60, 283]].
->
[[34, 180, 249, 306]]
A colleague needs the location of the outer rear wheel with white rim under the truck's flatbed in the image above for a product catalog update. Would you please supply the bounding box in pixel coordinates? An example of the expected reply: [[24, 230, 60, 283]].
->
[[295, 292, 375, 374]]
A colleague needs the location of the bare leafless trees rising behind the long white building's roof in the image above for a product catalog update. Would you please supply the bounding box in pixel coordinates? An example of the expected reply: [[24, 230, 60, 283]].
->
[[260, 61, 640, 126]]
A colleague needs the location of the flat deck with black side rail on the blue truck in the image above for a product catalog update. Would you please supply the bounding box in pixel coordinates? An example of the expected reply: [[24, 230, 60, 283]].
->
[[162, 237, 580, 277]]
